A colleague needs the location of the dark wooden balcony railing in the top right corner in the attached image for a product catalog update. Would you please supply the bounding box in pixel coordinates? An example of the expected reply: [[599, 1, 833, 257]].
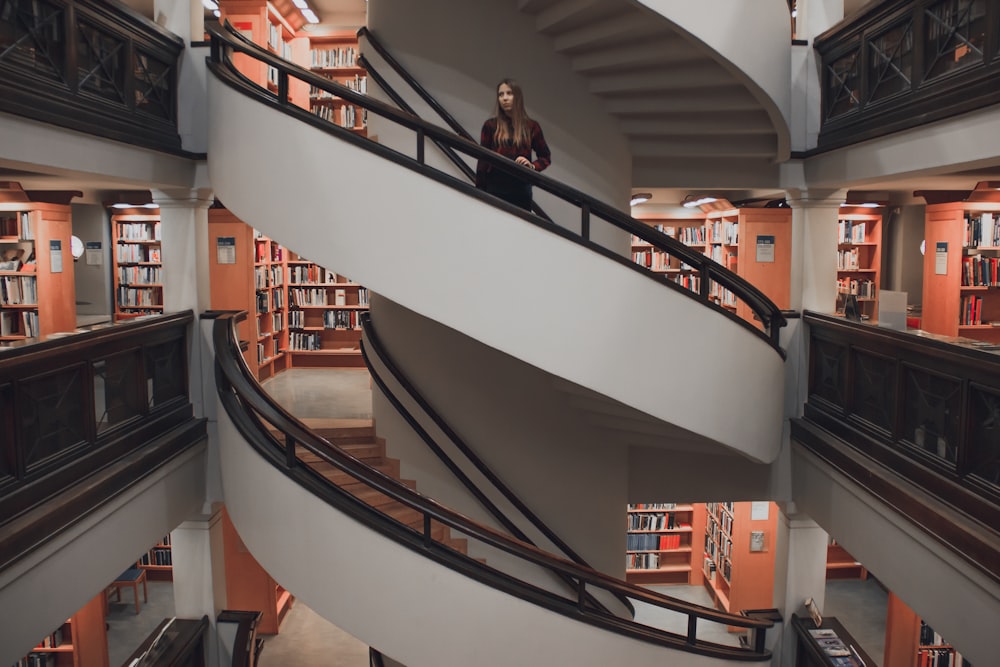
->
[[814, 0, 1000, 149]]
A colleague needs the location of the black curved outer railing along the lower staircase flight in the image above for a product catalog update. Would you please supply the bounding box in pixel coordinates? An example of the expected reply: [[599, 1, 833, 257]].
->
[[212, 311, 773, 662]]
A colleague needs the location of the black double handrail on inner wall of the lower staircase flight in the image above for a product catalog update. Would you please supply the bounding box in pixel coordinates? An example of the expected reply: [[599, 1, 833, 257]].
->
[[360, 313, 635, 614]]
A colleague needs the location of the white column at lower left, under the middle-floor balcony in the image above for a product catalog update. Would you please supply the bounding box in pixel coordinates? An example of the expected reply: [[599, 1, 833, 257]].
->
[[170, 504, 226, 667]]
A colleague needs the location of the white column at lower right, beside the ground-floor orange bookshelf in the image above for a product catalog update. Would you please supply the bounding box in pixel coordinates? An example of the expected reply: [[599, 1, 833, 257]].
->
[[772, 503, 829, 667]]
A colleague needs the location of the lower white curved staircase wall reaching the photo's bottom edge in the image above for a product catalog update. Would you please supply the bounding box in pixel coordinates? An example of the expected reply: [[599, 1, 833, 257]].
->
[[219, 407, 760, 667]]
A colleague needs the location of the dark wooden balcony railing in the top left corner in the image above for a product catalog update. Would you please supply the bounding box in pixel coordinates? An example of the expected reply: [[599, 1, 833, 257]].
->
[[0, 0, 184, 153]]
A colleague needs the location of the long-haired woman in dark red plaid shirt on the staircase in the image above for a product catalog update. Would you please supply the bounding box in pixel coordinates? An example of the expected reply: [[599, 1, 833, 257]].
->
[[476, 79, 552, 211]]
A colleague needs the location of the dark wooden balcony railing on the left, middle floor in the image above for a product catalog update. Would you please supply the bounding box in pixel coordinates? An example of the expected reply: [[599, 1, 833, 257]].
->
[[0, 312, 205, 567]]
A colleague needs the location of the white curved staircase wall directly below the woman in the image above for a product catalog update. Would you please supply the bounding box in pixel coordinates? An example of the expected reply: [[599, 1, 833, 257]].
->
[[209, 77, 784, 462]]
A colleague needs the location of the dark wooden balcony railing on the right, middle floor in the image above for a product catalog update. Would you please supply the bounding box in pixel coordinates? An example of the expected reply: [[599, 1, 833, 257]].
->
[[792, 312, 1000, 579]]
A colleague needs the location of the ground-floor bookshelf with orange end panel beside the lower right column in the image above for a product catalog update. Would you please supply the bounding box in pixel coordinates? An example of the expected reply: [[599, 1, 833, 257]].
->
[[702, 502, 778, 624]]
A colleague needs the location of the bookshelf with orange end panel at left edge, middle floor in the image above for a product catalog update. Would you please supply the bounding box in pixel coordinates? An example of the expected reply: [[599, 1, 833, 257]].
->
[[0, 201, 76, 344]]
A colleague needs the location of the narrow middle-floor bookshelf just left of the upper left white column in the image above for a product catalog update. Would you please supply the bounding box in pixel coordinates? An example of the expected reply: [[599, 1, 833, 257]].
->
[[111, 208, 163, 321]]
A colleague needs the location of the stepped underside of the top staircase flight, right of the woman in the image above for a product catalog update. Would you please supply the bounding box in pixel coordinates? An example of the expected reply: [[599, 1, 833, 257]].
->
[[518, 0, 789, 187]]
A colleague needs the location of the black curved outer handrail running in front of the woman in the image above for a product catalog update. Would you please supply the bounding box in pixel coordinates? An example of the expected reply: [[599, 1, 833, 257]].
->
[[206, 21, 787, 357]]
